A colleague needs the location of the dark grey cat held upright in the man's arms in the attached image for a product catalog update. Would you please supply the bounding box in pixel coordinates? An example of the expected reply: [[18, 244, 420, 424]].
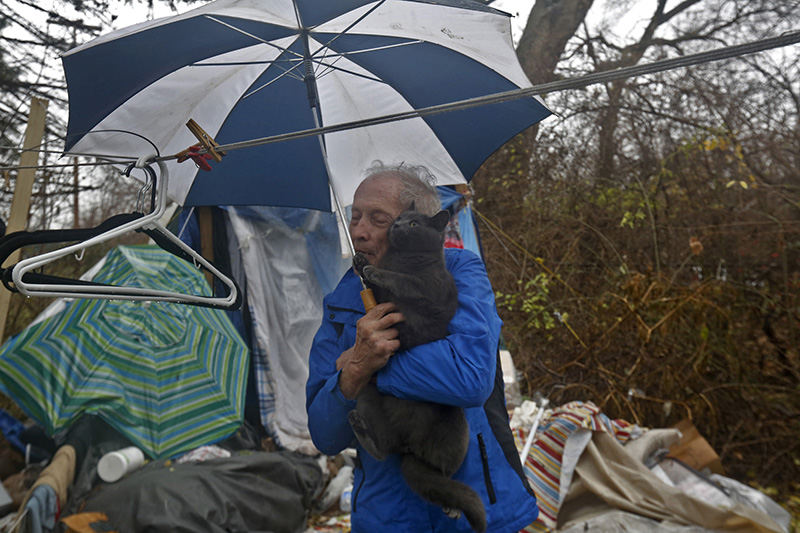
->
[[348, 206, 486, 532]]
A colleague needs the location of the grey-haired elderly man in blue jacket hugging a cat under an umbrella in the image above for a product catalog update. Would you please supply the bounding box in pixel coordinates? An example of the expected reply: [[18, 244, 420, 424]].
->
[[306, 165, 538, 533]]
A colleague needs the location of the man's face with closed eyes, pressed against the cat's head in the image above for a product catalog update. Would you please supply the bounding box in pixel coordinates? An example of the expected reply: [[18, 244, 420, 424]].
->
[[349, 174, 405, 265]]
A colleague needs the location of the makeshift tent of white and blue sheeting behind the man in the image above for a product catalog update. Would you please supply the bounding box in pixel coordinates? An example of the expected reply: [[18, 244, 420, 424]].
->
[[173, 187, 480, 454]]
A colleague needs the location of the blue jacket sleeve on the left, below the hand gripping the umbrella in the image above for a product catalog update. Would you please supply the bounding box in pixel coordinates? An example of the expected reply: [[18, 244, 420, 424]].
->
[[306, 303, 356, 455]]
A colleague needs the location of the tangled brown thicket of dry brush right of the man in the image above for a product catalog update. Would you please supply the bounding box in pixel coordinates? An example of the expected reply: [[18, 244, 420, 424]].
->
[[472, 131, 800, 497]]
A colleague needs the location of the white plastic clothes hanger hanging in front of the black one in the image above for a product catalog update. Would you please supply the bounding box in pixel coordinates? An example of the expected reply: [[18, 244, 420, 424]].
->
[[11, 156, 241, 309]]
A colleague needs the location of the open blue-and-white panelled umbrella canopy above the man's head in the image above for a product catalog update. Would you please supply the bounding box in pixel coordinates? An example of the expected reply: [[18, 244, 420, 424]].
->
[[63, 0, 550, 210]]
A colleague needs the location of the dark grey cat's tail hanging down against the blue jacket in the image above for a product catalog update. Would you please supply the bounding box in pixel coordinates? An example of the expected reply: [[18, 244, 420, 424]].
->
[[400, 455, 486, 533]]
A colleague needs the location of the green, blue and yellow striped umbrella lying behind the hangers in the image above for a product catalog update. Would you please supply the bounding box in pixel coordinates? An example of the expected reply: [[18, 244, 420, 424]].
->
[[0, 246, 249, 459]]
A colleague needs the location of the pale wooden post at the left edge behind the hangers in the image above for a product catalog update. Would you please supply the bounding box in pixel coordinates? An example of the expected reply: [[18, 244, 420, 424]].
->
[[0, 96, 48, 340]]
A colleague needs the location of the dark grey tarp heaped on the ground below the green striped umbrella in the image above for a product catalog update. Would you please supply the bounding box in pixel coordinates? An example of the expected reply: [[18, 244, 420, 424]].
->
[[76, 451, 322, 533]]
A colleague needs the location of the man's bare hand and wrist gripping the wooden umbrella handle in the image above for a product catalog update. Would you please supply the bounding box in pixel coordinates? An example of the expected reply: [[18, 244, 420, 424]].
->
[[336, 303, 404, 399]]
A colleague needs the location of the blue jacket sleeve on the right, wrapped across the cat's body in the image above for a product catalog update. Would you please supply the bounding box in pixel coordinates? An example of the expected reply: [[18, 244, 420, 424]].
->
[[378, 251, 502, 407]]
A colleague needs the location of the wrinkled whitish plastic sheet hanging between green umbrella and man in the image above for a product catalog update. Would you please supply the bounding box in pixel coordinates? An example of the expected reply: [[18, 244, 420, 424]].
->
[[228, 208, 350, 454]]
